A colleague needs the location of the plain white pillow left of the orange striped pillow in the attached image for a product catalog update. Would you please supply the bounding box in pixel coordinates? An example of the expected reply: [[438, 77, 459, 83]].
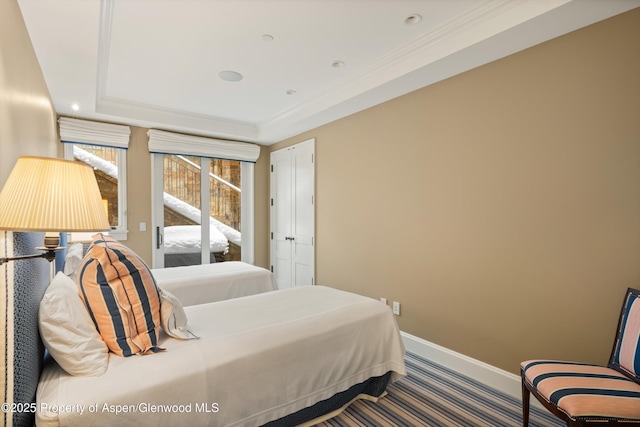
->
[[38, 272, 109, 376]]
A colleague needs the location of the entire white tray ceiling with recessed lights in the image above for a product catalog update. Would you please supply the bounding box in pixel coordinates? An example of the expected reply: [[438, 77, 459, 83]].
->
[[18, 0, 640, 145]]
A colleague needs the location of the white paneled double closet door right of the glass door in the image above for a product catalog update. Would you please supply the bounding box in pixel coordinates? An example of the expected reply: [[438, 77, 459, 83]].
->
[[270, 139, 315, 289]]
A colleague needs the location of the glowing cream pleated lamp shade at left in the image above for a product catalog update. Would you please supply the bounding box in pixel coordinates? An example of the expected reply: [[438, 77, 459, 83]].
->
[[0, 157, 110, 231]]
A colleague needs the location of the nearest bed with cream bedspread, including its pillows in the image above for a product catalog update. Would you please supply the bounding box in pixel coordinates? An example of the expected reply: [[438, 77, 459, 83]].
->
[[26, 238, 406, 427]]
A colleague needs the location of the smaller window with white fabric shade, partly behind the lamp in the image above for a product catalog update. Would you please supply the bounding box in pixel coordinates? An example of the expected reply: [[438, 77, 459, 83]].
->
[[58, 117, 130, 240]]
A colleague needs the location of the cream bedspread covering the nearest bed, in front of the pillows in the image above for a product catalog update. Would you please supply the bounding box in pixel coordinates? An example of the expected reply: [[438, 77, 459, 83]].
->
[[36, 286, 406, 426]]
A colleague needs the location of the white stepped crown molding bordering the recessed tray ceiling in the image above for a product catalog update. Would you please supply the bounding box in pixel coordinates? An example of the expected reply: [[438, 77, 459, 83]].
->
[[89, 0, 631, 144]]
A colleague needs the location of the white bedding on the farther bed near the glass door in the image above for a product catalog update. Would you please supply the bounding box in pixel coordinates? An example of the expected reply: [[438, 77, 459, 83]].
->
[[151, 261, 276, 306]]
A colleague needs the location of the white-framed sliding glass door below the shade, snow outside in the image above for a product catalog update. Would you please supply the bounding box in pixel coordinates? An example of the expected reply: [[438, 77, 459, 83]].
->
[[153, 154, 253, 268]]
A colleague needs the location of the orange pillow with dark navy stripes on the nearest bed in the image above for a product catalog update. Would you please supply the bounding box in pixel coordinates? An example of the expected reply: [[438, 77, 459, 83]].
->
[[77, 233, 162, 356]]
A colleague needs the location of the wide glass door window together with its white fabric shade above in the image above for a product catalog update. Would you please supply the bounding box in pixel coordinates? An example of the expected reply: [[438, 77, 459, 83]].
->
[[148, 129, 260, 268]]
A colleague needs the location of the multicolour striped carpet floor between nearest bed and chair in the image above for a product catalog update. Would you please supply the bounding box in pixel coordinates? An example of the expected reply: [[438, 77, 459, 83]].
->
[[317, 352, 565, 427]]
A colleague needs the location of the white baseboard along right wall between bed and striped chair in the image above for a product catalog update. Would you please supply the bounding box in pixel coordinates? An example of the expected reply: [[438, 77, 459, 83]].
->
[[401, 332, 542, 407]]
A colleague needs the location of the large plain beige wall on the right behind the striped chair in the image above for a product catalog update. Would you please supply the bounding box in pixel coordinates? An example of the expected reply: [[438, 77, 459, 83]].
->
[[268, 9, 640, 373]]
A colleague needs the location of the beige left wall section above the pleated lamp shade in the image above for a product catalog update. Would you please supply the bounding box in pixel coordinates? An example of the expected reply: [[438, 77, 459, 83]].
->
[[0, 0, 57, 181]]
